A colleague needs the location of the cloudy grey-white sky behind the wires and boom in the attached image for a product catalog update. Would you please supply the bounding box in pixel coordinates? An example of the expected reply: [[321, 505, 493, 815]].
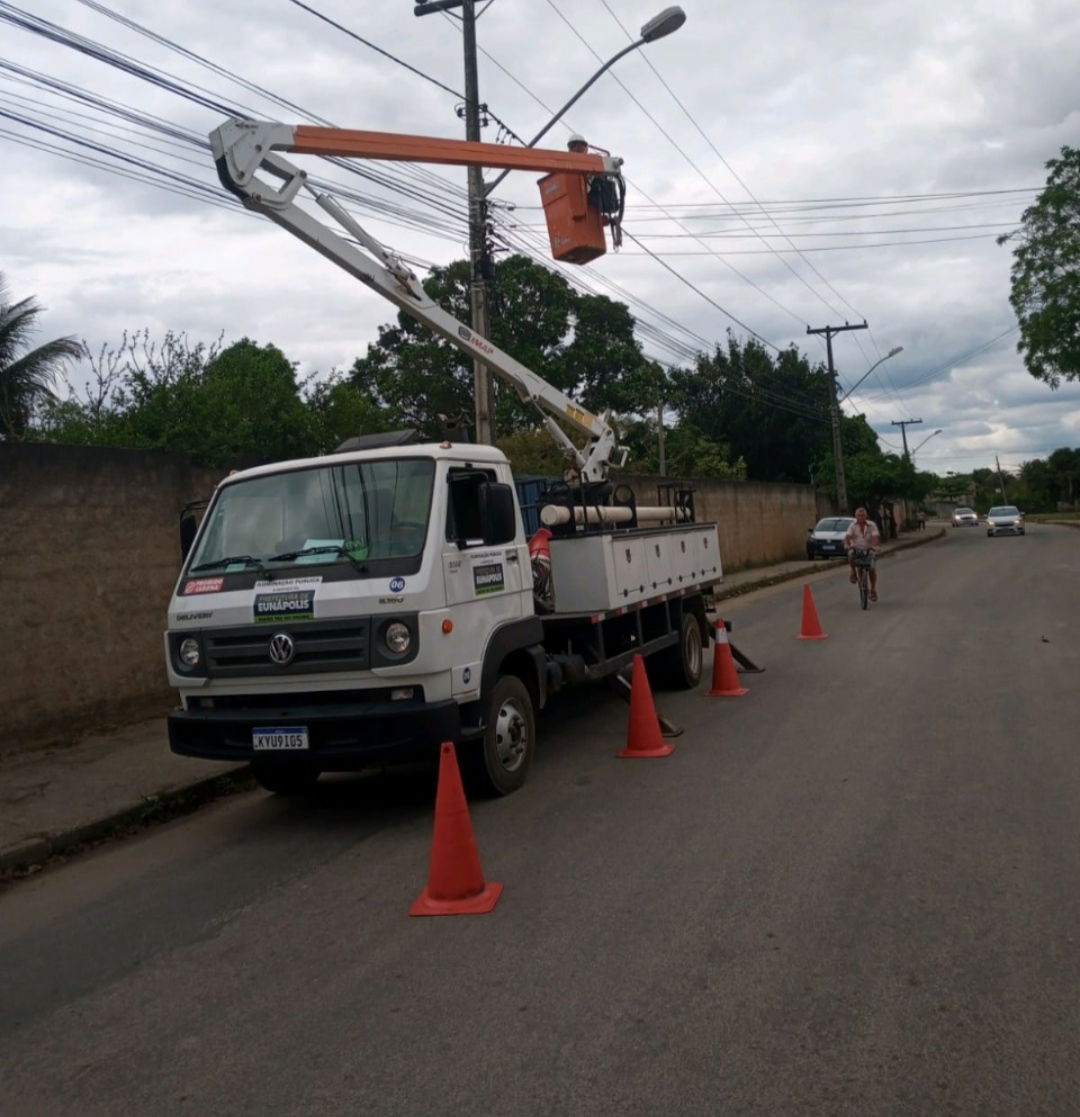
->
[[0, 0, 1080, 474]]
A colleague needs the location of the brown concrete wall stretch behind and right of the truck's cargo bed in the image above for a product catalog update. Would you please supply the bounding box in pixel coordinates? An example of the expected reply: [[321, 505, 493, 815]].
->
[[618, 476, 820, 571]]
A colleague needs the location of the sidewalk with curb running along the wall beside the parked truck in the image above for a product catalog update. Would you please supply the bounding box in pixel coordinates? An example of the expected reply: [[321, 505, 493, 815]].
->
[[0, 524, 945, 882]]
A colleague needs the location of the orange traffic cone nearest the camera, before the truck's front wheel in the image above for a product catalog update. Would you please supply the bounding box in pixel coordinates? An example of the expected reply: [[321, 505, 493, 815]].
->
[[409, 742, 503, 915]]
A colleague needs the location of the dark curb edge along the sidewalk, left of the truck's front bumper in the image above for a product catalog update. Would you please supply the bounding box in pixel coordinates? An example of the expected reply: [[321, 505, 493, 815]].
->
[[0, 764, 255, 885]]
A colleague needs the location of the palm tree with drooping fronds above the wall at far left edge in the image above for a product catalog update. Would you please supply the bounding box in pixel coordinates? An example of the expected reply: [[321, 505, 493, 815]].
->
[[0, 273, 85, 439]]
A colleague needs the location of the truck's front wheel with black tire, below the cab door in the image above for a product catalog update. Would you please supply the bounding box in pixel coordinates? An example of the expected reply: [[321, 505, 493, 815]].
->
[[461, 675, 536, 799]]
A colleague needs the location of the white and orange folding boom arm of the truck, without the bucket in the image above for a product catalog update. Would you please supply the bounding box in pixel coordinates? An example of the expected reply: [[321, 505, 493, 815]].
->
[[210, 120, 622, 483]]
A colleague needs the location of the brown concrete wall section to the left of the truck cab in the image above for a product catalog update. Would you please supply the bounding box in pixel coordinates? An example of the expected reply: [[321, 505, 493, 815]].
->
[[0, 442, 221, 754]]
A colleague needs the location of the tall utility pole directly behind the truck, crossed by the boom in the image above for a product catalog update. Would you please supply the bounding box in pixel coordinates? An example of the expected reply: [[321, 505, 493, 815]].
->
[[413, 0, 495, 446]]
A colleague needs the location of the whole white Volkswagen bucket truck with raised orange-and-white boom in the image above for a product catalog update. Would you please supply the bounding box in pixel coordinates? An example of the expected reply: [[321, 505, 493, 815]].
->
[[165, 121, 721, 794]]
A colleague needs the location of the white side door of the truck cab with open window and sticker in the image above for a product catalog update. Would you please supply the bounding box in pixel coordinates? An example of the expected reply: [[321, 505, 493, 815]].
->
[[442, 468, 533, 697]]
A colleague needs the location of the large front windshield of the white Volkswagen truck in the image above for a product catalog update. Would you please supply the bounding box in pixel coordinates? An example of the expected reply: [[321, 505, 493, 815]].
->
[[189, 458, 434, 573]]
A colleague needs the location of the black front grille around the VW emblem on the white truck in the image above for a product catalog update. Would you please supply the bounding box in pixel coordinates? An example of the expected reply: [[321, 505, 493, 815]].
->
[[203, 619, 372, 679]]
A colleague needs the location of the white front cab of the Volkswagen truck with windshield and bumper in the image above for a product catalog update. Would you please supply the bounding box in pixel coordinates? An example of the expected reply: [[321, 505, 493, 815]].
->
[[165, 442, 545, 793]]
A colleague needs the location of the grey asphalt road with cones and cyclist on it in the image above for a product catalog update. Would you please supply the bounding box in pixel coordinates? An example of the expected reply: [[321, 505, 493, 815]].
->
[[0, 525, 1080, 1117]]
